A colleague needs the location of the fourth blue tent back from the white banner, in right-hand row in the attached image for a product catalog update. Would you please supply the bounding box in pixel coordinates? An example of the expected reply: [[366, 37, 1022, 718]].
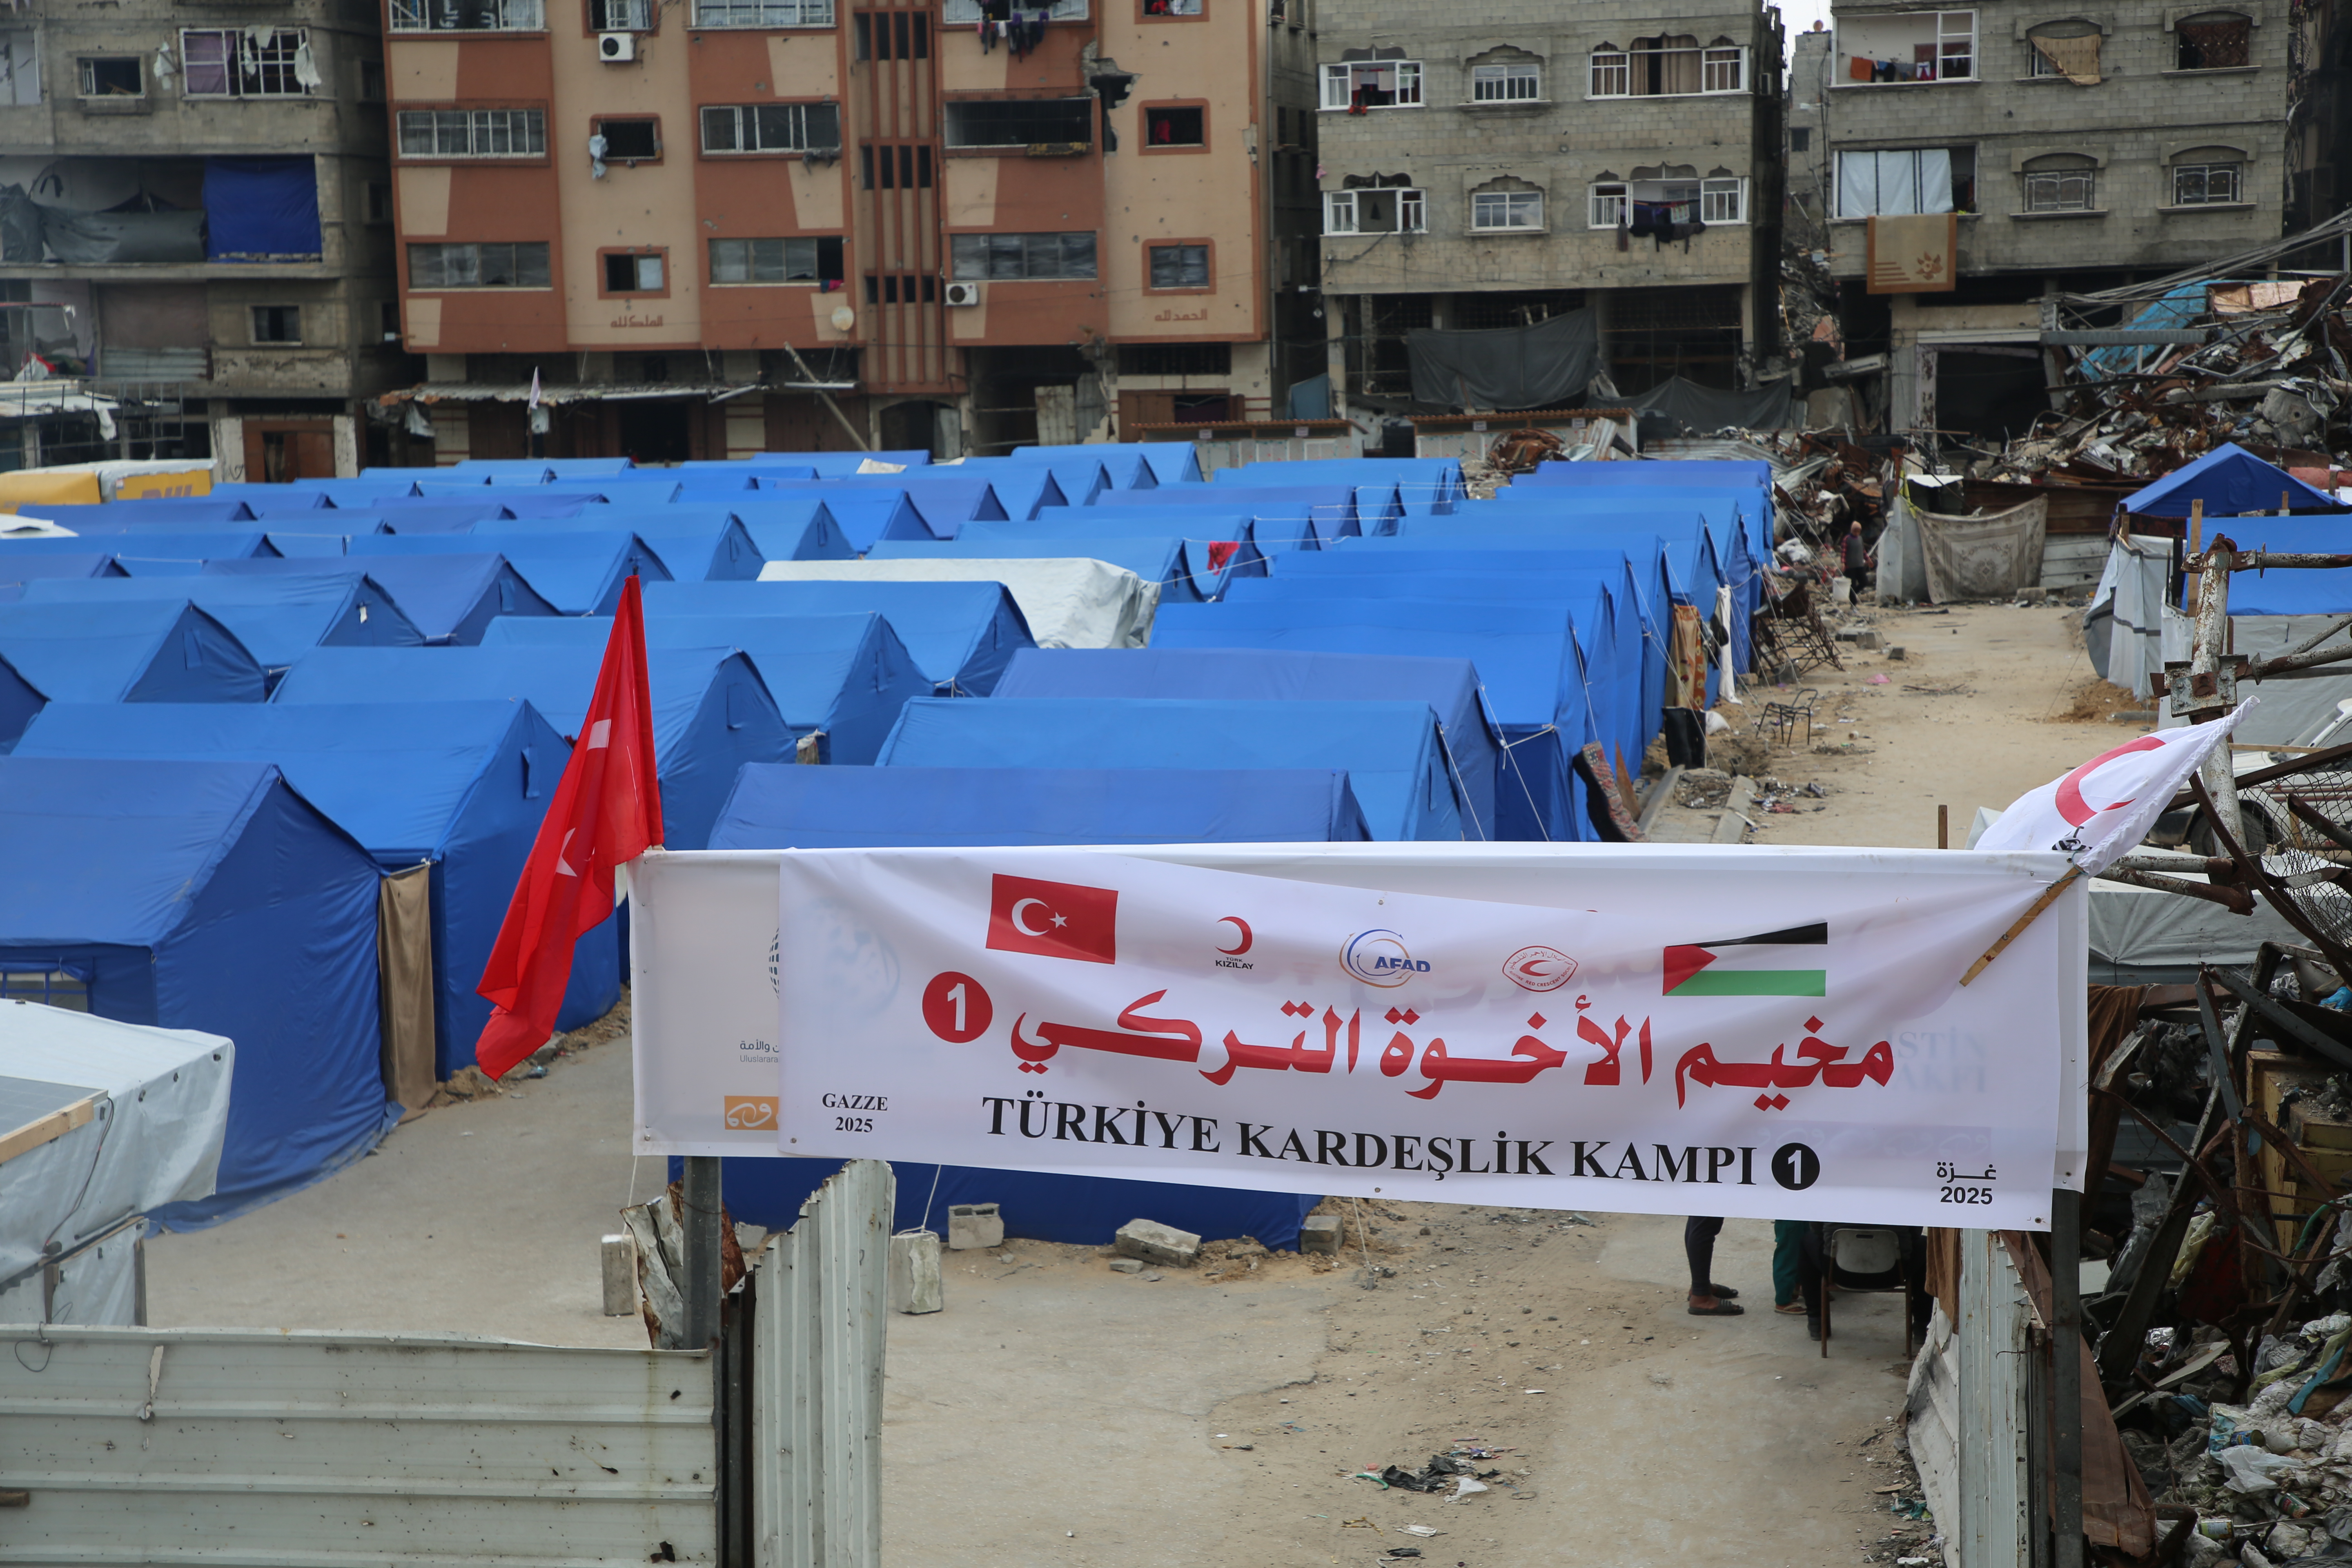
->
[[1152, 599, 1599, 842]]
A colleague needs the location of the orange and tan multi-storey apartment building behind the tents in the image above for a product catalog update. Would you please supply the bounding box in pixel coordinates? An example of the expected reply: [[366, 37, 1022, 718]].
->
[[386, 0, 1324, 463]]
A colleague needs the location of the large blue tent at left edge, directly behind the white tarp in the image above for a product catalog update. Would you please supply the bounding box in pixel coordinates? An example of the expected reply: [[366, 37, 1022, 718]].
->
[[0, 757, 400, 1229]]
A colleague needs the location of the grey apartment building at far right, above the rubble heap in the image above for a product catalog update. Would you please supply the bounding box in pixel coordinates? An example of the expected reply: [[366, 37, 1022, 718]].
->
[[1790, 0, 2347, 442]]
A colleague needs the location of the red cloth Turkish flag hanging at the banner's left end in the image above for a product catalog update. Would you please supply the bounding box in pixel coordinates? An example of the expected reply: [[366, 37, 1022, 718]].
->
[[473, 578, 661, 1079]]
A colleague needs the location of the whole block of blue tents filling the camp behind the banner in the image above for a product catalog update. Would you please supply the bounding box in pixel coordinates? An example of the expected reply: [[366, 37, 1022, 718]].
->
[[0, 444, 1771, 1244]]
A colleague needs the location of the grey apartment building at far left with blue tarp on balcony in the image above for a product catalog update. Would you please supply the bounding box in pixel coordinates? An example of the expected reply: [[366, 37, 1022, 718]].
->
[[0, 0, 414, 479]]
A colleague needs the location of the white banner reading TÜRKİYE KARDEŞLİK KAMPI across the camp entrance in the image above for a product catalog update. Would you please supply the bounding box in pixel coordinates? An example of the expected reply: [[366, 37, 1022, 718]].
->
[[658, 844, 2086, 1229]]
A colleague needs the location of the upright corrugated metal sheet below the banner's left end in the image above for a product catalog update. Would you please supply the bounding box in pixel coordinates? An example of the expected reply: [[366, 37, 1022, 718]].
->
[[750, 1159, 891, 1568]]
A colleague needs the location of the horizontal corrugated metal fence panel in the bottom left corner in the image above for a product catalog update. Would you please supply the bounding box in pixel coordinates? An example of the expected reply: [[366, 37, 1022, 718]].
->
[[0, 1328, 717, 1568]]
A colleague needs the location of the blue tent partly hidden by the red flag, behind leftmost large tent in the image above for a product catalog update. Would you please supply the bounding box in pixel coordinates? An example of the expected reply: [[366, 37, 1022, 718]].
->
[[16, 703, 621, 1081]]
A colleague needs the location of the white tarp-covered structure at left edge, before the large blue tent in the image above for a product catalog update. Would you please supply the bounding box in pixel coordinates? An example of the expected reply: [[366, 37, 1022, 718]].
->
[[0, 999, 235, 1326]]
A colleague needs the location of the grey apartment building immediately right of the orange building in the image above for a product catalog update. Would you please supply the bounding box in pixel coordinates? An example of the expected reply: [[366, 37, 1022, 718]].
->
[[1317, 0, 1783, 423]]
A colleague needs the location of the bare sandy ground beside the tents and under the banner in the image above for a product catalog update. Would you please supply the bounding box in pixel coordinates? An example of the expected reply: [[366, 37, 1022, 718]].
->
[[148, 592, 2138, 1568]]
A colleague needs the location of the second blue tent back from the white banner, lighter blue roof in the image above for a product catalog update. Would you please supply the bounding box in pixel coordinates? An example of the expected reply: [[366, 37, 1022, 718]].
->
[[882, 696, 1465, 839]]
